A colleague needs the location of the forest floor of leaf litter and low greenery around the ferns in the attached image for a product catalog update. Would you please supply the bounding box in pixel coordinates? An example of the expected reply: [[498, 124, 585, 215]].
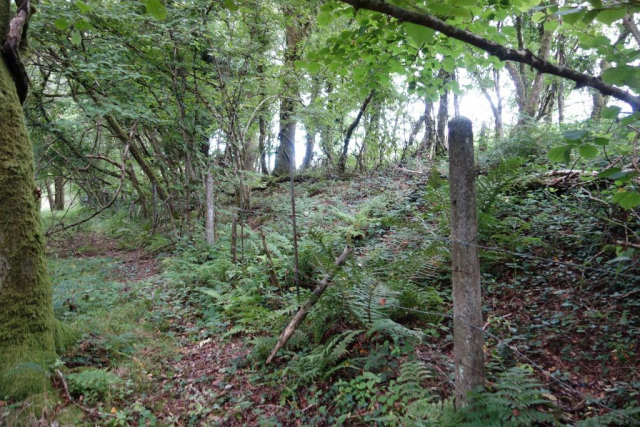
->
[[0, 162, 640, 426]]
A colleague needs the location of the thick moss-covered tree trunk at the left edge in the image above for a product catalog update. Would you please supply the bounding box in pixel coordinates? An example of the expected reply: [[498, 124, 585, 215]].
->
[[0, 0, 56, 400]]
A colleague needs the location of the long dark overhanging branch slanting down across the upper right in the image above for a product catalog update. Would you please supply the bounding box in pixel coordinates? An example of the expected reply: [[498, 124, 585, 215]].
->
[[341, 0, 640, 111]]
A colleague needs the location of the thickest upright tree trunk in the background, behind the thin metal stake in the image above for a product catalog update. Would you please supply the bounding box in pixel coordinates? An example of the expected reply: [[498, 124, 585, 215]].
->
[[273, 17, 305, 176]]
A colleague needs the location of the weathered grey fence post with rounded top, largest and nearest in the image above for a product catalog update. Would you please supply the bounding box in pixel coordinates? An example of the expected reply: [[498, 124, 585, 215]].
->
[[449, 116, 484, 407]]
